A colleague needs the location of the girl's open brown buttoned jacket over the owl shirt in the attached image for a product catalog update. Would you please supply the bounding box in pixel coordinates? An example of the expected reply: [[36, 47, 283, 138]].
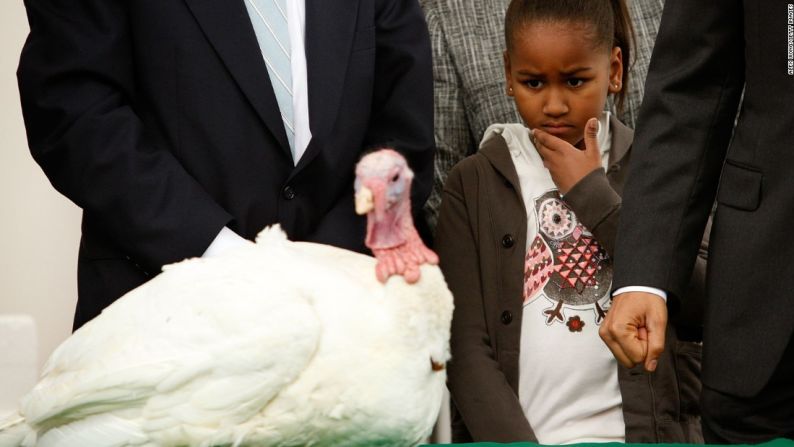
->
[[436, 118, 707, 443]]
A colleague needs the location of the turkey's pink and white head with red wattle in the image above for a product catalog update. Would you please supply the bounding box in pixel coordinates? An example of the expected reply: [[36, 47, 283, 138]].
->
[[355, 149, 438, 283]]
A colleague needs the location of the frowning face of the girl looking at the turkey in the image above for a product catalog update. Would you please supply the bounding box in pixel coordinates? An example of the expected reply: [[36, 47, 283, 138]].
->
[[504, 21, 623, 149]]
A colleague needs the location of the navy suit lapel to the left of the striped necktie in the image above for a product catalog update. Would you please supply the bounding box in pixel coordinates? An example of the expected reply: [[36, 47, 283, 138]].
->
[[185, 0, 292, 158]]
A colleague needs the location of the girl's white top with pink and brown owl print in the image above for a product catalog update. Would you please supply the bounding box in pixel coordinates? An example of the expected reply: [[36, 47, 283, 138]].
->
[[476, 112, 625, 444]]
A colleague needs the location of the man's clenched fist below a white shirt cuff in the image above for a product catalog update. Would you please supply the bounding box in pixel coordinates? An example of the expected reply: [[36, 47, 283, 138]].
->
[[598, 292, 667, 371]]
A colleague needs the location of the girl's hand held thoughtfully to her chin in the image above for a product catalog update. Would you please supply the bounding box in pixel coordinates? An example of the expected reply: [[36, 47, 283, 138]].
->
[[532, 118, 601, 195]]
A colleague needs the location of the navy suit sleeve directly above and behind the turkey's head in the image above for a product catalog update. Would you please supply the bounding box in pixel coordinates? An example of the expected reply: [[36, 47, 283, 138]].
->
[[365, 0, 435, 220]]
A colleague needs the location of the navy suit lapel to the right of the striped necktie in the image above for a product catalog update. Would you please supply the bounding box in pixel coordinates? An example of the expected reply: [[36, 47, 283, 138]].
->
[[297, 0, 358, 170]]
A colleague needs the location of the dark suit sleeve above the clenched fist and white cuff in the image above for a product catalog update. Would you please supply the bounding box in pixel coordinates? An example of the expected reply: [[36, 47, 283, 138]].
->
[[613, 0, 744, 296]]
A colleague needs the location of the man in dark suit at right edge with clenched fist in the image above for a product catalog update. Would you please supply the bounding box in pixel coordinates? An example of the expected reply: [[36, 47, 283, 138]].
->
[[602, 0, 794, 443]]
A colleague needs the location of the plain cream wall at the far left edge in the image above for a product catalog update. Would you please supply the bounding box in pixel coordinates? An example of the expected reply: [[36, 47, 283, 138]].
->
[[0, 0, 80, 382]]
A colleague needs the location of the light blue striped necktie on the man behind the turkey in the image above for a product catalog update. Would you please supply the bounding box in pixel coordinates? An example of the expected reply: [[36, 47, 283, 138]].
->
[[245, 0, 295, 156]]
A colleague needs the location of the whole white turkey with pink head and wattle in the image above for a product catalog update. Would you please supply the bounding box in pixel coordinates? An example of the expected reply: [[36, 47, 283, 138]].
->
[[0, 150, 452, 447]]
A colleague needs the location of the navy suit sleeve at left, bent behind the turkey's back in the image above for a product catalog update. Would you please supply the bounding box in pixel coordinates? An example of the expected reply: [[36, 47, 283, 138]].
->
[[18, 0, 231, 270]]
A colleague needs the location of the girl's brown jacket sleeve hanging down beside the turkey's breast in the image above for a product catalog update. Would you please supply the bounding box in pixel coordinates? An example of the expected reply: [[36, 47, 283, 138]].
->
[[435, 165, 535, 442]]
